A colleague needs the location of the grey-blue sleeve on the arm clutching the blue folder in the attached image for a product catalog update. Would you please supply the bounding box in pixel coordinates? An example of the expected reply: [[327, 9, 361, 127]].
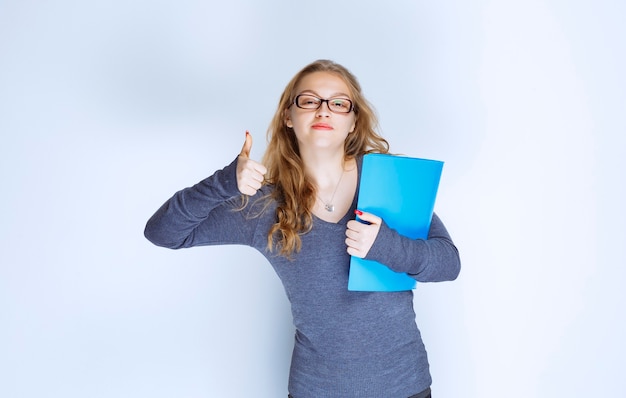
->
[[365, 214, 461, 282]]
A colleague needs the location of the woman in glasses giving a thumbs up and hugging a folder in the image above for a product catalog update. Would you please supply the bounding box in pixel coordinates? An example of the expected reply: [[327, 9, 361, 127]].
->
[[145, 60, 460, 398]]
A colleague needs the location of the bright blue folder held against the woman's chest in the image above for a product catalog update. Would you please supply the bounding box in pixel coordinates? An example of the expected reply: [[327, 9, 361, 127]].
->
[[348, 154, 443, 292]]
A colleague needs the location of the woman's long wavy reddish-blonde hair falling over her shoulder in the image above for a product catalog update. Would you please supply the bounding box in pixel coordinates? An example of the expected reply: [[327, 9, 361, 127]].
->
[[263, 60, 389, 257]]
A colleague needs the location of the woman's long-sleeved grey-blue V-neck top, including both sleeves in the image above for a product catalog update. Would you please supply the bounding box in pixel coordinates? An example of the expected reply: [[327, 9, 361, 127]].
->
[[145, 158, 460, 398]]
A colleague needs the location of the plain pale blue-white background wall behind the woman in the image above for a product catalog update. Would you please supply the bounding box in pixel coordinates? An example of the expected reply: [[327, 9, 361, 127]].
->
[[0, 0, 626, 398]]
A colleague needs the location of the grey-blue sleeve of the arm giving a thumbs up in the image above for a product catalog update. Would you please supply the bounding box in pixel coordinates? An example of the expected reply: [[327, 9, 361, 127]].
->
[[144, 159, 252, 249]]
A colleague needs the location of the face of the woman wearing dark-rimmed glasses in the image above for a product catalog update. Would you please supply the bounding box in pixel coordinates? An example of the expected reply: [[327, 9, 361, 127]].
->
[[285, 72, 356, 151]]
